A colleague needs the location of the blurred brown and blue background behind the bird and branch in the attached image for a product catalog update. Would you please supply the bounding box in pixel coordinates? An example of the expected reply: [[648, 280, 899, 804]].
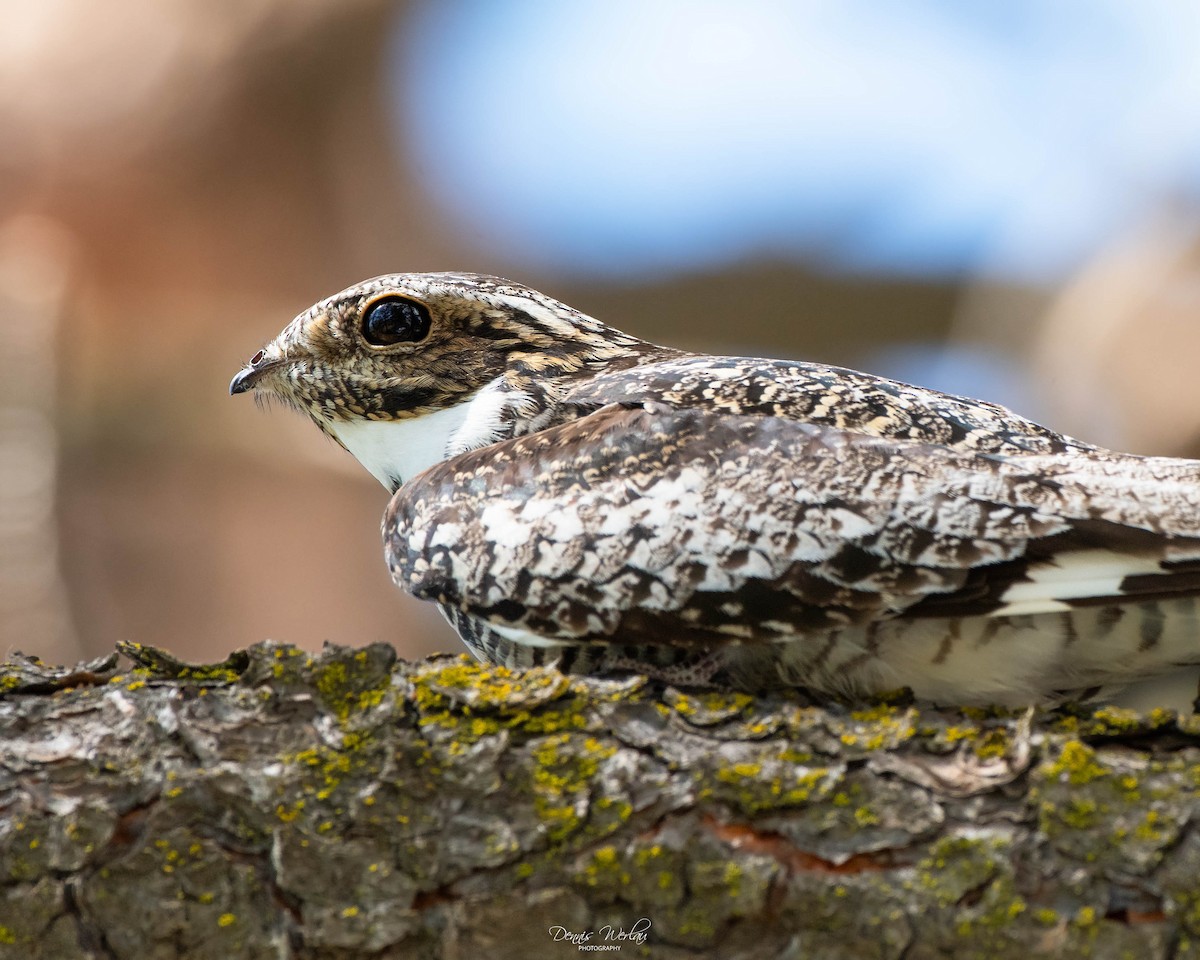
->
[[0, 0, 1200, 705]]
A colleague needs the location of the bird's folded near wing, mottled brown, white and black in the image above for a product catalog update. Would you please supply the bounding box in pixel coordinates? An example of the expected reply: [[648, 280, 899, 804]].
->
[[384, 404, 1200, 644]]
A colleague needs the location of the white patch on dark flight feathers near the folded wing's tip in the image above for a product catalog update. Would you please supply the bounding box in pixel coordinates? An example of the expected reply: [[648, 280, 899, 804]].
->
[[991, 550, 1163, 617]]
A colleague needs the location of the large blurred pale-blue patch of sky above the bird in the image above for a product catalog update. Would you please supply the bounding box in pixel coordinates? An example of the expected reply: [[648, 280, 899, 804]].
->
[[391, 0, 1200, 281]]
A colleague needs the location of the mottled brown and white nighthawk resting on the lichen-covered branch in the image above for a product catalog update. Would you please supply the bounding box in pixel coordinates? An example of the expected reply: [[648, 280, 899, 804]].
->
[[229, 274, 1200, 703]]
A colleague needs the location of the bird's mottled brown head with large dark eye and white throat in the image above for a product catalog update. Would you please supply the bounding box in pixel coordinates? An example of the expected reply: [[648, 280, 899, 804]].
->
[[229, 274, 649, 488]]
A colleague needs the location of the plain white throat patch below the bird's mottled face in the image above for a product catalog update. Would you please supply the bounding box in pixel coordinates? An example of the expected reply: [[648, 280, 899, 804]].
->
[[329, 378, 526, 490]]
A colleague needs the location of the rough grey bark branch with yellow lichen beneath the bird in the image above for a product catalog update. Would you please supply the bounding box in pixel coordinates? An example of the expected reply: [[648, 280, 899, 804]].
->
[[0, 644, 1200, 960]]
